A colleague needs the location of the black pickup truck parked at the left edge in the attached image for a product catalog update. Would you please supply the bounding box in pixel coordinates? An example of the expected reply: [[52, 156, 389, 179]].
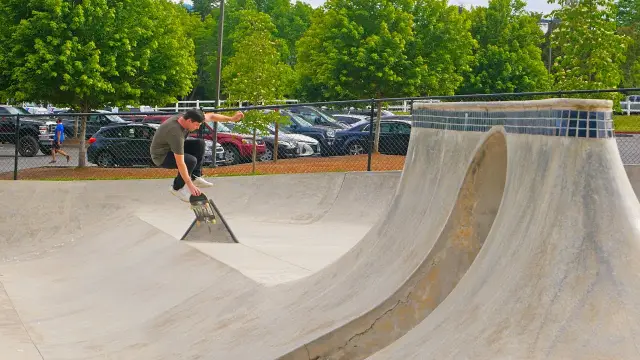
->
[[0, 105, 51, 157]]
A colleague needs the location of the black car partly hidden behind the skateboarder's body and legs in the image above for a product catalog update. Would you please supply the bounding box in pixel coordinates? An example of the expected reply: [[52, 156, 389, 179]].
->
[[87, 123, 225, 167]]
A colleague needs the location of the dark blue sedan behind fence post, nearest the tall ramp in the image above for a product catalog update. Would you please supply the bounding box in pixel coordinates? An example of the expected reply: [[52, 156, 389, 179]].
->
[[334, 120, 411, 155]]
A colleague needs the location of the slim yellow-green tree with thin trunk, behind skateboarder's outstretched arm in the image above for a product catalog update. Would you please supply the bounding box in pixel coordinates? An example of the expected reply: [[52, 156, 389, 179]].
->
[[222, 10, 293, 171]]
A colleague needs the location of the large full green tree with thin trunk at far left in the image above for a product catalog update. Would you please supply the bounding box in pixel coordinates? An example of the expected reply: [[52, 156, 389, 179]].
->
[[0, 0, 196, 167]]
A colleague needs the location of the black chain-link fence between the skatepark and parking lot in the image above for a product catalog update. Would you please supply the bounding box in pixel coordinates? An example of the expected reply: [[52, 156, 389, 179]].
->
[[0, 89, 640, 180]]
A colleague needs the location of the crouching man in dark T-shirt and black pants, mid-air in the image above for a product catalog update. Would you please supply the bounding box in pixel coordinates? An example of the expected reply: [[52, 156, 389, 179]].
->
[[150, 109, 244, 202]]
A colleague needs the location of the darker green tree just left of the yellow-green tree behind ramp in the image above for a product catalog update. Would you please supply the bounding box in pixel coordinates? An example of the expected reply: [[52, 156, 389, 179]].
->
[[460, 0, 549, 94]]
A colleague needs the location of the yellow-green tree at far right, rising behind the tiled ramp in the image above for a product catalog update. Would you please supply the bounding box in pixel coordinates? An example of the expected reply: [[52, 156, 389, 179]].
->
[[552, 0, 628, 100]]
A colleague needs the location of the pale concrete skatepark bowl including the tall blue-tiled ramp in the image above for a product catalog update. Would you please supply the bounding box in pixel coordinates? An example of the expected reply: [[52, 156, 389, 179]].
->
[[0, 99, 640, 360]]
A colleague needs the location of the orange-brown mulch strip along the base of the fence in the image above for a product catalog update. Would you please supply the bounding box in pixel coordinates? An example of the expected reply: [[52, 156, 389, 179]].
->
[[0, 155, 405, 180]]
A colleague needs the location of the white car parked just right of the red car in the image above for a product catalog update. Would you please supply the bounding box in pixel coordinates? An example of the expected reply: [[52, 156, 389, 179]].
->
[[260, 125, 321, 161]]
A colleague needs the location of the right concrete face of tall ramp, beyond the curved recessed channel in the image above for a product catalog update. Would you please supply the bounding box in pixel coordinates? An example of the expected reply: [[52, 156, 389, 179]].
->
[[370, 101, 640, 360]]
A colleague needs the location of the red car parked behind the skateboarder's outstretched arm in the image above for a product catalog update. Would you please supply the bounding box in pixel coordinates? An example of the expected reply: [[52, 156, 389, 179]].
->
[[142, 115, 266, 165]]
